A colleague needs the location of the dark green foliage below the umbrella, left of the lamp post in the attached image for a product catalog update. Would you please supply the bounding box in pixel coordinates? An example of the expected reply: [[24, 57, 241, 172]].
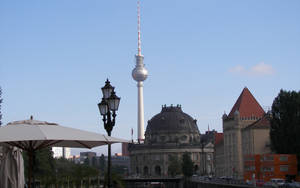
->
[[23, 148, 99, 187]]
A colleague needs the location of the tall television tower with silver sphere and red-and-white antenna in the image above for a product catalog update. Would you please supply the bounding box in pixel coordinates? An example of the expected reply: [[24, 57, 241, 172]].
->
[[132, 0, 148, 141]]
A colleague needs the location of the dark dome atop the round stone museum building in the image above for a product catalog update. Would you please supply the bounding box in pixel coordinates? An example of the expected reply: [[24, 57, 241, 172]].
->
[[146, 105, 199, 134]]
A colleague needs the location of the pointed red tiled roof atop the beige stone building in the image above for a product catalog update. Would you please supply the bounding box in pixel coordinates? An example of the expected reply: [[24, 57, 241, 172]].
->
[[228, 87, 265, 118]]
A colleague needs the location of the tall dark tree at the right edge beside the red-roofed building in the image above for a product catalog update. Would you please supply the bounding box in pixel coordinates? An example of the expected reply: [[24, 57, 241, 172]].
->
[[270, 90, 300, 157]]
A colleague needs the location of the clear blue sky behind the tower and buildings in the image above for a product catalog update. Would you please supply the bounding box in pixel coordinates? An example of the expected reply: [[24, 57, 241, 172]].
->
[[0, 0, 300, 152]]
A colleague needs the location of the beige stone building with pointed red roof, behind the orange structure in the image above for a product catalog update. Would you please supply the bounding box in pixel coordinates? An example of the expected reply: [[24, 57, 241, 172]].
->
[[217, 87, 270, 179]]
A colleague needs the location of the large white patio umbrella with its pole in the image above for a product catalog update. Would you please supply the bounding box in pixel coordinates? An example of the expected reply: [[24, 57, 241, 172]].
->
[[0, 116, 128, 188]]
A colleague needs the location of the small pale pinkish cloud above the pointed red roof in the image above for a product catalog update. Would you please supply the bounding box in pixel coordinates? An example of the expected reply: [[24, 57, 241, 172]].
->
[[229, 62, 275, 76]]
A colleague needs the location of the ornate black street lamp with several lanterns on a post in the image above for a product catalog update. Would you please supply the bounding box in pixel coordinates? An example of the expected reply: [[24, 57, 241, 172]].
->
[[98, 79, 120, 188]]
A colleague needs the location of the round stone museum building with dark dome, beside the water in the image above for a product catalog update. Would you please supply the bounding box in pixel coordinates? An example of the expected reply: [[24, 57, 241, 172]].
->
[[128, 105, 214, 177]]
